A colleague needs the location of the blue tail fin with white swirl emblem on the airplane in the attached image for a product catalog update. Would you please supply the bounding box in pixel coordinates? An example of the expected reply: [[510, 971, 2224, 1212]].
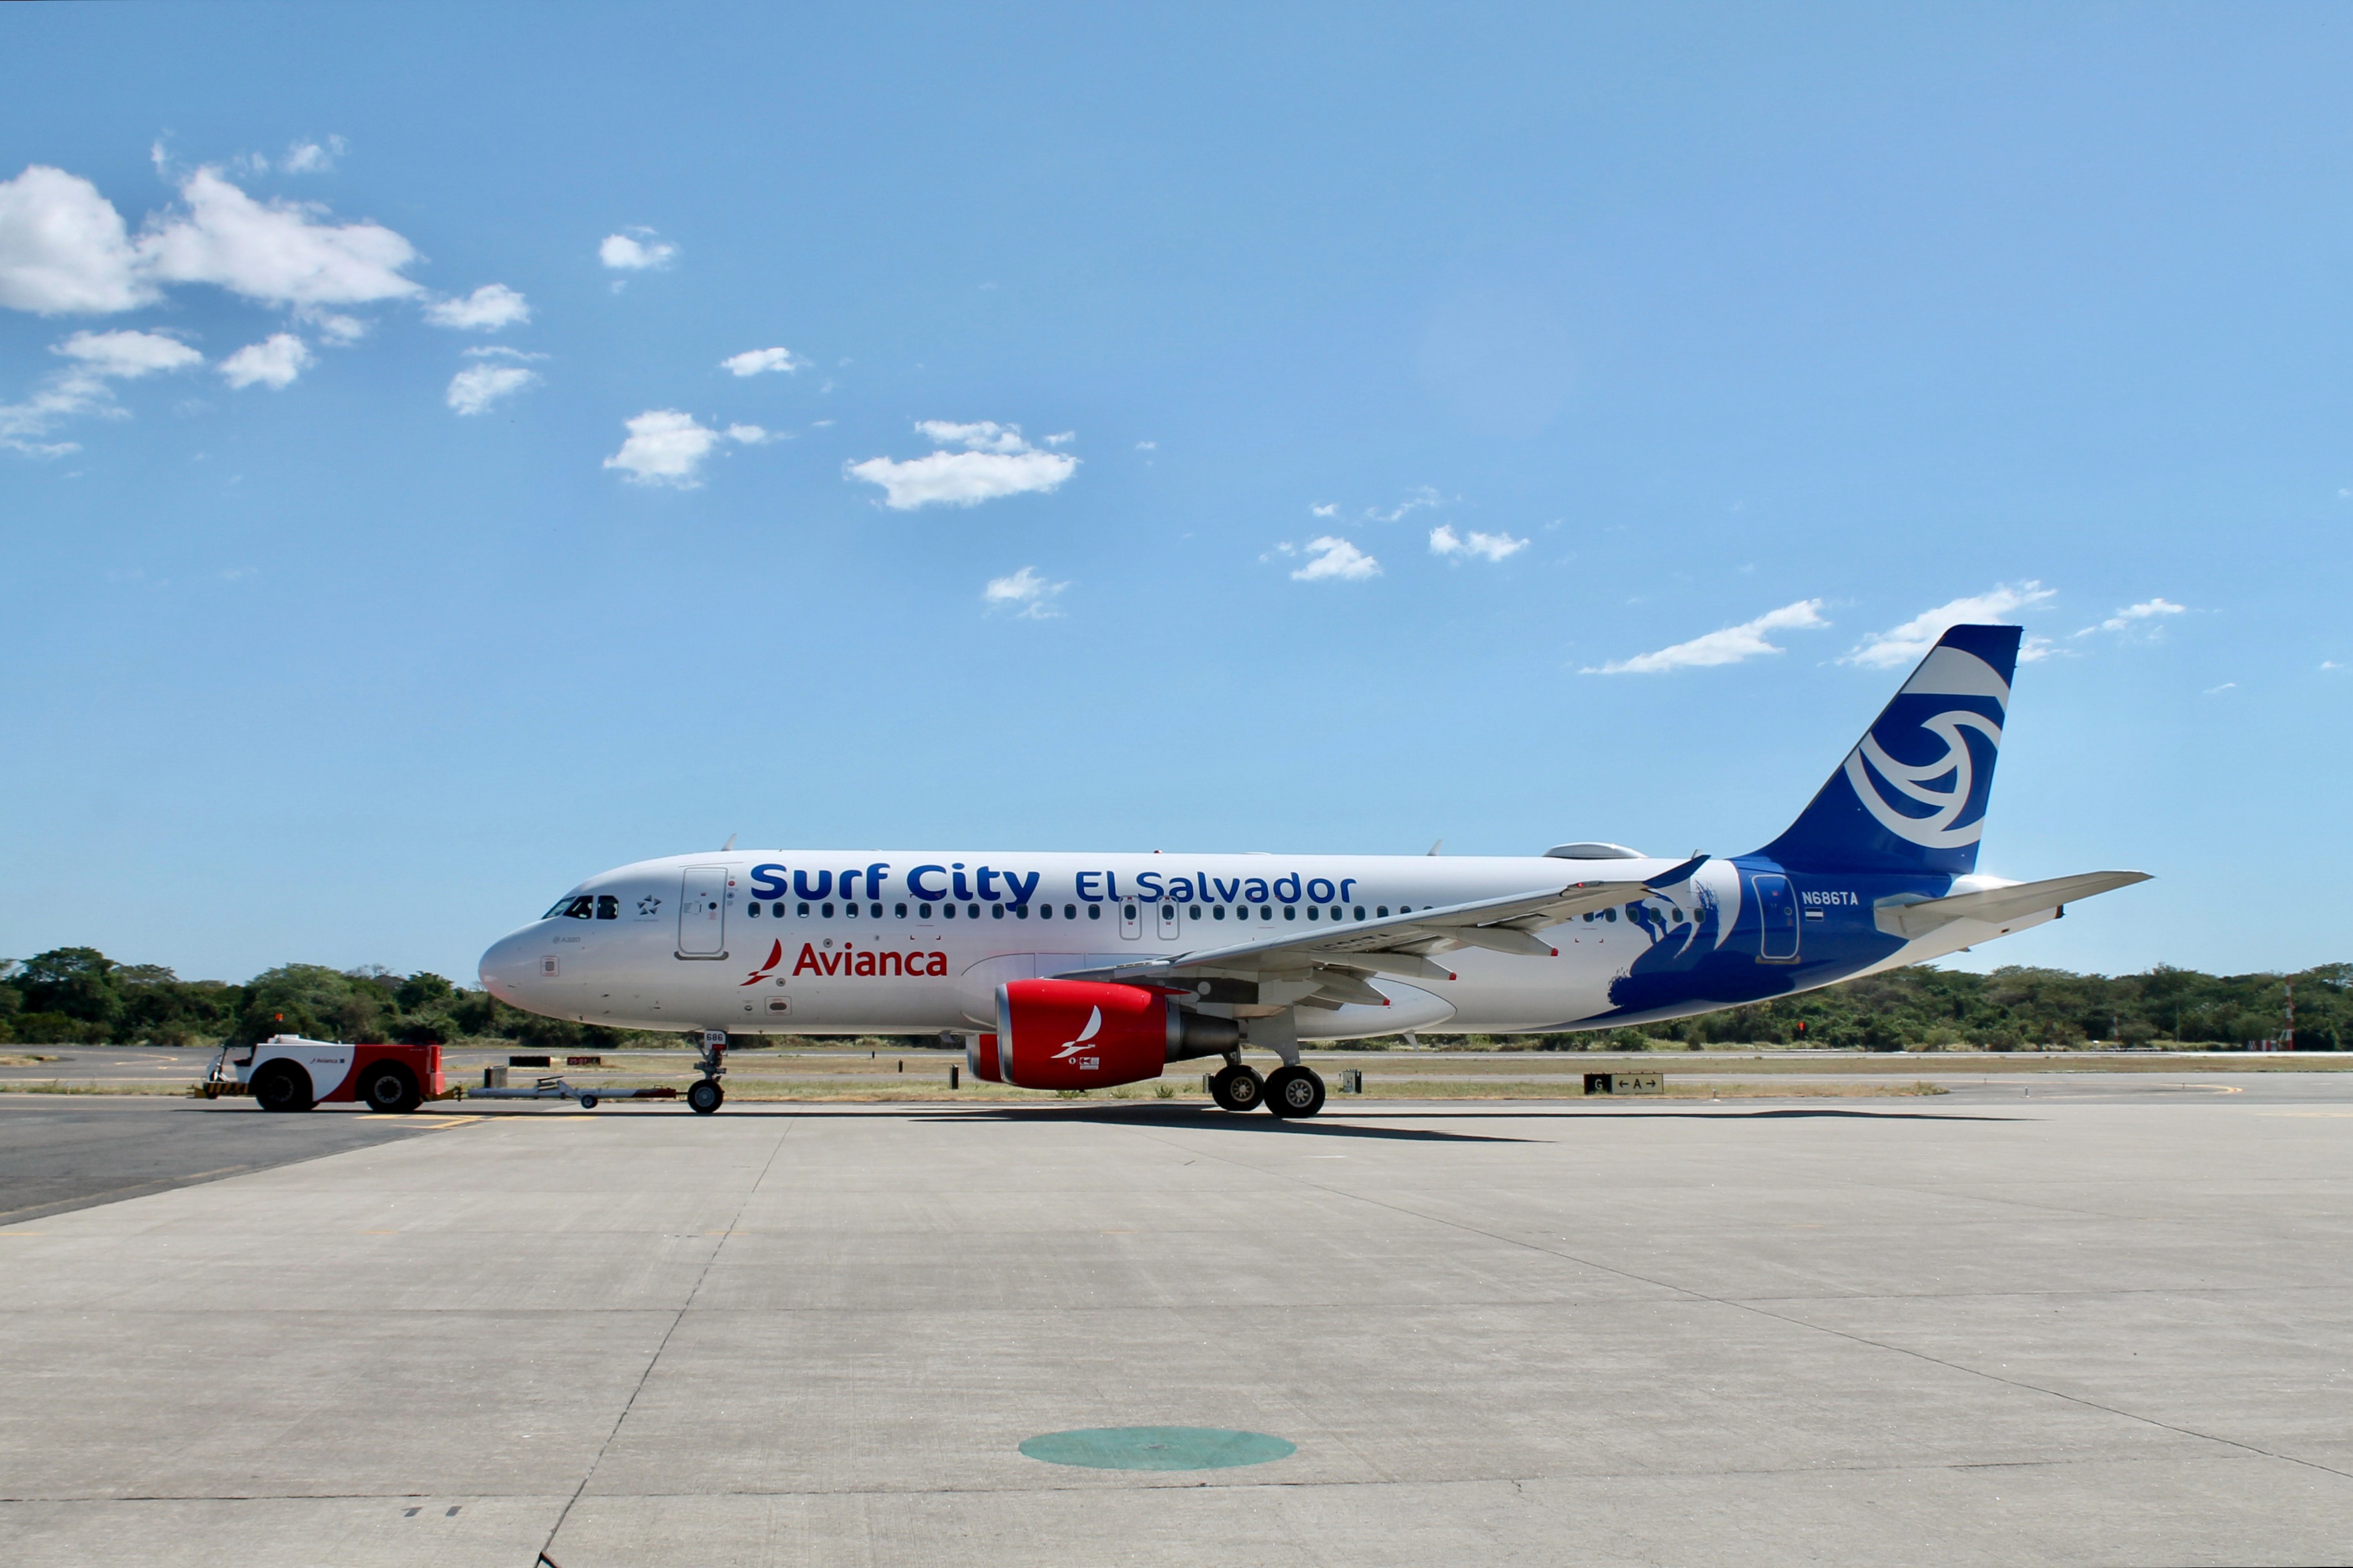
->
[[1757, 626, 2021, 876]]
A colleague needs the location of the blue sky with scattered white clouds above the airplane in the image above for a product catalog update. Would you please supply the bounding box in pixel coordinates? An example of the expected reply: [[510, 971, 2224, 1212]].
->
[[0, 5, 2353, 980]]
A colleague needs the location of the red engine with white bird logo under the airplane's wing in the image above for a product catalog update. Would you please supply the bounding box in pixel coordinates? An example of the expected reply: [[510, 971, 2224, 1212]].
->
[[992, 980, 1243, 1088]]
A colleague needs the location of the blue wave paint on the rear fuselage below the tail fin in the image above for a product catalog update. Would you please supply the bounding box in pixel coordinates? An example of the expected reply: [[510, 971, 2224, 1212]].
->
[[1558, 855, 1953, 1029]]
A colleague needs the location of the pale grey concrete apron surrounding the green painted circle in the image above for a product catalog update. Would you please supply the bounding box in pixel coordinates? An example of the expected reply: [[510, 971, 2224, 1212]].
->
[[0, 1074, 2353, 1568]]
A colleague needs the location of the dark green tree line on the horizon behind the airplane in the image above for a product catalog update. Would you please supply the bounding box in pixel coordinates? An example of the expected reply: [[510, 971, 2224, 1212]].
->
[[0, 946, 2353, 1050]]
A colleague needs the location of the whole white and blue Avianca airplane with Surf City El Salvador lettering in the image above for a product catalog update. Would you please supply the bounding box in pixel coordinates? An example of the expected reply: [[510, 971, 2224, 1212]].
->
[[482, 626, 2146, 1116]]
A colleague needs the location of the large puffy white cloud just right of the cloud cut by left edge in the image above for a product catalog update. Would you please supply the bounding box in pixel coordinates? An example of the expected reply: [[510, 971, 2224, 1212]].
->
[[139, 169, 421, 306]]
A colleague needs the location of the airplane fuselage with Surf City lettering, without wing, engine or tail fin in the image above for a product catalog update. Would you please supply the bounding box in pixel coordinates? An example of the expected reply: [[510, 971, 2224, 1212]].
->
[[482, 850, 2050, 1041]]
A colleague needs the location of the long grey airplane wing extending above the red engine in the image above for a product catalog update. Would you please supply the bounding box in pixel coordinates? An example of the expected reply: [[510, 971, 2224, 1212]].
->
[[1059, 855, 1708, 1008]]
